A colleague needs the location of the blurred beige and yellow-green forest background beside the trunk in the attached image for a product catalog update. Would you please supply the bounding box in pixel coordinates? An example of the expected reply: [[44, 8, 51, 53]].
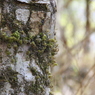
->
[[52, 0, 95, 95]]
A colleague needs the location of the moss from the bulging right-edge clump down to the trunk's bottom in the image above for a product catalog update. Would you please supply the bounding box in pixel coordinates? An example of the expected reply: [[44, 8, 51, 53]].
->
[[25, 33, 57, 95]]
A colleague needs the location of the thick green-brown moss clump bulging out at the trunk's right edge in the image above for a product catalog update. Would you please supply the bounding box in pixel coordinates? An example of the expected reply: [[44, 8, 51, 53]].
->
[[29, 33, 57, 67]]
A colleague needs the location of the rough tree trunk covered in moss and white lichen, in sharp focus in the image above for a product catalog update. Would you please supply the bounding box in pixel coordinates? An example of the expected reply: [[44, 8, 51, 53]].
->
[[0, 0, 56, 95]]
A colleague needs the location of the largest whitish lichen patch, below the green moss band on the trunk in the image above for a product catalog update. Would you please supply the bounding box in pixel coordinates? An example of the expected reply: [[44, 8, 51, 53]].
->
[[16, 53, 35, 81]]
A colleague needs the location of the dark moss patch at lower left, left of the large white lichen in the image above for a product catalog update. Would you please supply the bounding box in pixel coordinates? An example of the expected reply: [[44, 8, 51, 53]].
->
[[0, 67, 18, 88]]
